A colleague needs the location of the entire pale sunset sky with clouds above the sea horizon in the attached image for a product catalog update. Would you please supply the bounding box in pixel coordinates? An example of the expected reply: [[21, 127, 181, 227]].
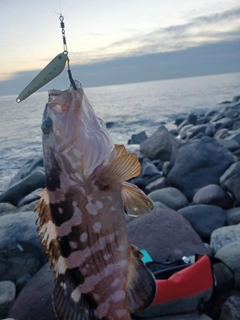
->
[[0, 0, 240, 95]]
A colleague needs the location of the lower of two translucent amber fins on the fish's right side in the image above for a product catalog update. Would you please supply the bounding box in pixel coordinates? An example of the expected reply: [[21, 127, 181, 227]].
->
[[122, 182, 153, 216]]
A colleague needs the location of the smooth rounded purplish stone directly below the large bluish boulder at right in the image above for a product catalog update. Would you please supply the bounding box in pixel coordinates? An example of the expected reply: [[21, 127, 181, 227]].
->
[[193, 184, 233, 209]]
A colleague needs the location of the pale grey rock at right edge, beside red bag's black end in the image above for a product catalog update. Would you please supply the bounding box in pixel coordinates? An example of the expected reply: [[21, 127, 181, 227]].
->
[[215, 242, 240, 289]]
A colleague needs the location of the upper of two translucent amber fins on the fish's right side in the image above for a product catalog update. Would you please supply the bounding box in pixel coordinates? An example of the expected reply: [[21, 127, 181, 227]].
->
[[97, 153, 141, 189]]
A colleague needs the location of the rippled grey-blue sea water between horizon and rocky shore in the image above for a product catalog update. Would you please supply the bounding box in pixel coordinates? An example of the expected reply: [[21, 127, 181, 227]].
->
[[0, 73, 240, 192]]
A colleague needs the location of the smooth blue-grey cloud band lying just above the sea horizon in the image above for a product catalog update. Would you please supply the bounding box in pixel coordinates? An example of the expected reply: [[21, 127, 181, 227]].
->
[[0, 40, 240, 95]]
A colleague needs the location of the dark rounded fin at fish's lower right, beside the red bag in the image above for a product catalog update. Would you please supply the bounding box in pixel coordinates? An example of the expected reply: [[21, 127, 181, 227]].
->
[[124, 246, 157, 312]]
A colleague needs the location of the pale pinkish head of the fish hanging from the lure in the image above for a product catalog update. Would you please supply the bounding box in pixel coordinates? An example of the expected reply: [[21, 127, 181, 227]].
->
[[42, 81, 114, 180]]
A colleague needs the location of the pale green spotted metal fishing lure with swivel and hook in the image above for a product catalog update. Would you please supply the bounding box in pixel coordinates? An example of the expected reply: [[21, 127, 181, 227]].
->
[[16, 15, 77, 103]]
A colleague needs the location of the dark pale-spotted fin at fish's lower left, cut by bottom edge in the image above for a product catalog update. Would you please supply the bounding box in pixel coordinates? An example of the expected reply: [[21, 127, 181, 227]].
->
[[53, 270, 99, 320]]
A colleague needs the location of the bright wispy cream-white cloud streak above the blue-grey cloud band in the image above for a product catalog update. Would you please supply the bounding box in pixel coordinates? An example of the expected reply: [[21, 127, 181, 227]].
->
[[70, 7, 240, 63]]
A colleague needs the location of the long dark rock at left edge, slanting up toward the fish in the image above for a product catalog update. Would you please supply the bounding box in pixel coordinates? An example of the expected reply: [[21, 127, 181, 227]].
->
[[0, 167, 45, 206]]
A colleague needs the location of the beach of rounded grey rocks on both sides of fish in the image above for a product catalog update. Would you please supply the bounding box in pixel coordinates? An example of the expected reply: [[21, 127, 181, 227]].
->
[[0, 96, 240, 320]]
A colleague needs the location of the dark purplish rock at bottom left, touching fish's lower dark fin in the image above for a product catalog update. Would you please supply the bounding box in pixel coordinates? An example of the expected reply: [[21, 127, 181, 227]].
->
[[8, 263, 58, 320]]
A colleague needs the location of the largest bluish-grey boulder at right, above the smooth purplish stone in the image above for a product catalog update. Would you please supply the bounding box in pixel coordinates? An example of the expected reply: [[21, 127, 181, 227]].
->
[[167, 137, 234, 200]]
